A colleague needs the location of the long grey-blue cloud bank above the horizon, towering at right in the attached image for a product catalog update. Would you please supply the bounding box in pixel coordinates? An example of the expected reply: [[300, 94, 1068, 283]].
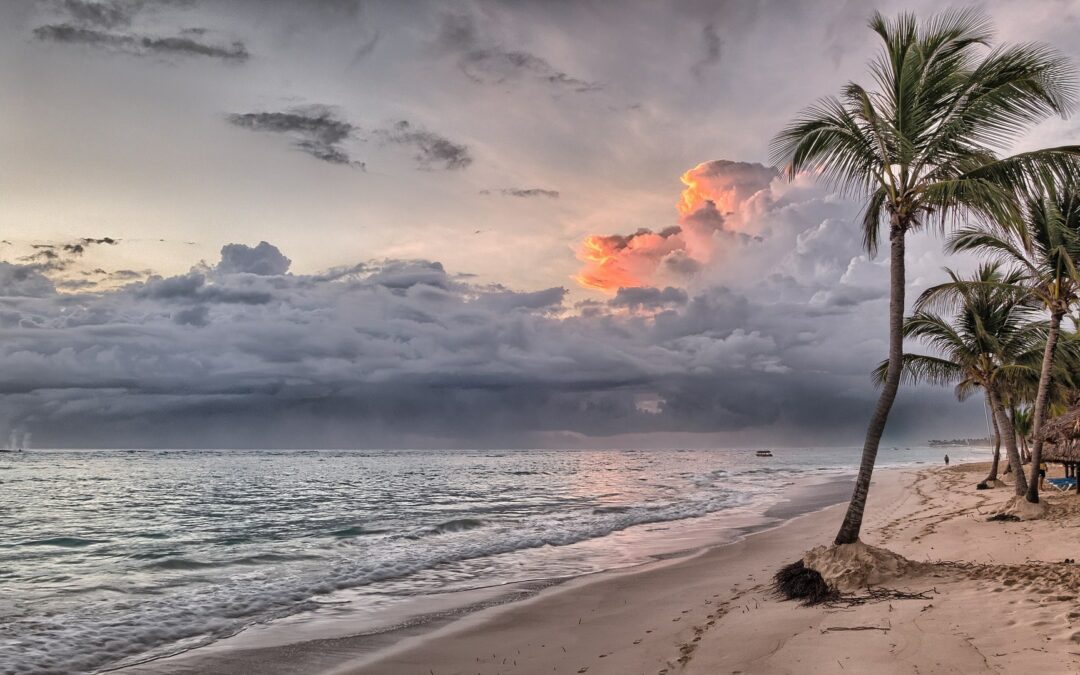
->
[[0, 170, 976, 447]]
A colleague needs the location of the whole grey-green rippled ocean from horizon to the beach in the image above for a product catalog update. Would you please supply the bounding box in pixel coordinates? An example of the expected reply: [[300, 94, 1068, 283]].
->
[[0, 448, 988, 675]]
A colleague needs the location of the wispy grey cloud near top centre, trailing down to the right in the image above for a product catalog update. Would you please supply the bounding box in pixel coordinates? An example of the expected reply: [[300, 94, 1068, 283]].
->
[[435, 13, 602, 92]]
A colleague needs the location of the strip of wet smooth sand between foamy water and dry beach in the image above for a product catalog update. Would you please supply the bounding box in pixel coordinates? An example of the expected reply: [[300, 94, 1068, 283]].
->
[[113, 468, 864, 674]]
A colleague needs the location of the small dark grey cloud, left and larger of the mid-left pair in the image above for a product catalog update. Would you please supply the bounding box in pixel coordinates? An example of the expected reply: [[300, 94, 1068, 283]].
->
[[228, 106, 364, 168]]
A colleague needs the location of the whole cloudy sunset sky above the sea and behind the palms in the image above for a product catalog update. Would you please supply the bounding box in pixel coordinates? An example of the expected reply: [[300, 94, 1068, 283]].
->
[[0, 0, 1080, 448]]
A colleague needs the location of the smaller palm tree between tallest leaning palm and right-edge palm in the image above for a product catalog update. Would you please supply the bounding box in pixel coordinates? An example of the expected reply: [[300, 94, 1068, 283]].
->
[[875, 264, 1044, 496]]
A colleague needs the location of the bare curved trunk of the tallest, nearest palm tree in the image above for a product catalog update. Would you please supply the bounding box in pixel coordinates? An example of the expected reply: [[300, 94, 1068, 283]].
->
[[834, 216, 907, 545]]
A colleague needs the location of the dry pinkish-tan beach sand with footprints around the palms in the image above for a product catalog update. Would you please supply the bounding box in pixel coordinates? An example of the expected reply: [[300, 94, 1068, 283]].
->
[[334, 464, 1080, 675]]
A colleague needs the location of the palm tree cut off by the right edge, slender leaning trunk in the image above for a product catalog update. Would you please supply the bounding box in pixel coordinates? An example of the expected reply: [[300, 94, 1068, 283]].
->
[[948, 187, 1080, 503]]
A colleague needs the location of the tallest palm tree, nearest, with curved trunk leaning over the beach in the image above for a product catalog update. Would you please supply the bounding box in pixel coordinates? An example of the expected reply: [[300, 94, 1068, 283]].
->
[[772, 10, 1080, 544]]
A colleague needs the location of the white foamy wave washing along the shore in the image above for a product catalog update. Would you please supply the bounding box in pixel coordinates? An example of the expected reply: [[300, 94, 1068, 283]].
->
[[0, 481, 760, 674]]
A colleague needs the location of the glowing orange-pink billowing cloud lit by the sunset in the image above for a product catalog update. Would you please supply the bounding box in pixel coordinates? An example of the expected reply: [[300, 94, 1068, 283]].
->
[[575, 160, 775, 293]]
